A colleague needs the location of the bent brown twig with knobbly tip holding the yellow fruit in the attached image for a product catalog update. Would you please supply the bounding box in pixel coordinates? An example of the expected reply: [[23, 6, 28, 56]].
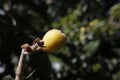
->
[[15, 38, 44, 80]]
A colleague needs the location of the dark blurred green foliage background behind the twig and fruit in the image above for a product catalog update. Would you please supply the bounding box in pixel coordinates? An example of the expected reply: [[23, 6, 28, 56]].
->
[[0, 0, 120, 80]]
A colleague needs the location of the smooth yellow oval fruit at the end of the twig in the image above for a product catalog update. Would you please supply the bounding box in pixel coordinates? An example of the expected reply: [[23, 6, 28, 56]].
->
[[42, 29, 67, 52]]
